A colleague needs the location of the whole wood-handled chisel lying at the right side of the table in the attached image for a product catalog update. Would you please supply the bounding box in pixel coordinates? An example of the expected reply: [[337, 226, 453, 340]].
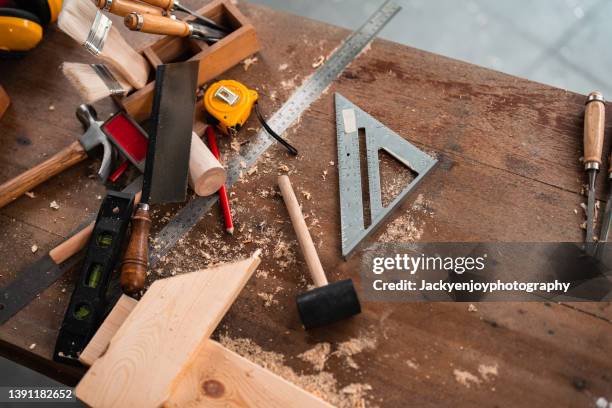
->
[[584, 91, 605, 247]]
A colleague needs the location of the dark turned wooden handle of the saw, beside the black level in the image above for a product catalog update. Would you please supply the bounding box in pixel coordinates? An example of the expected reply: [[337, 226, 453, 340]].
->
[[120, 204, 151, 295]]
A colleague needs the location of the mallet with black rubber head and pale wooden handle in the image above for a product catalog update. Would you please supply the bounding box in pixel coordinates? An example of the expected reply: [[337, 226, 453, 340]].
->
[[278, 176, 361, 330]]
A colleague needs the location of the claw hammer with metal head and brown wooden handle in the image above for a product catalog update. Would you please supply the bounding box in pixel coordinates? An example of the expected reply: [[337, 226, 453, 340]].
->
[[0, 105, 112, 208]]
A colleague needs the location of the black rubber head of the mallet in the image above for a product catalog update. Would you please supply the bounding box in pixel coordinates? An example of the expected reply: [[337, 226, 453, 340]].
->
[[297, 279, 361, 330]]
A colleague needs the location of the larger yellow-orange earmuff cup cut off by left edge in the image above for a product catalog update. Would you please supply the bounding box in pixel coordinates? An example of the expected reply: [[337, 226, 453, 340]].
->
[[0, 16, 43, 51]]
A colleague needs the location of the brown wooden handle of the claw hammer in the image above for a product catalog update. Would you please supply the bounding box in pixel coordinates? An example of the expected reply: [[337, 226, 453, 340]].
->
[[0, 141, 87, 208]]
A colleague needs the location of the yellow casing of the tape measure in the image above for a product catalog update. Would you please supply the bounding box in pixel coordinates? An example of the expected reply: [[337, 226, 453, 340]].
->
[[204, 80, 259, 136]]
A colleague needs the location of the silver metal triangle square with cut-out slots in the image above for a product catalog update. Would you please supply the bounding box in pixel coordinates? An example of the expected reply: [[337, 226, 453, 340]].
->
[[335, 93, 438, 258]]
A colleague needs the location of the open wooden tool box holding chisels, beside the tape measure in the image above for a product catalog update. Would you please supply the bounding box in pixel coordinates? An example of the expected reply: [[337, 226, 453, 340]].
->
[[119, 0, 260, 121]]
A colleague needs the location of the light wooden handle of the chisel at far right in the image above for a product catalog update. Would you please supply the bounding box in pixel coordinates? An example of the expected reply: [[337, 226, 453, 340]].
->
[[584, 91, 606, 170]]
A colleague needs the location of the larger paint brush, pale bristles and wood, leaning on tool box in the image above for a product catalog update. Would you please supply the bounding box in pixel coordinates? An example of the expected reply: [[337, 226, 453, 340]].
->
[[58, 0, 151, 89]]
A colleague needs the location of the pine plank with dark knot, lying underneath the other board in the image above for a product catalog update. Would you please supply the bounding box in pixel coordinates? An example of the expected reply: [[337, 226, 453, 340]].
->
[[79, 295, 331, 408]]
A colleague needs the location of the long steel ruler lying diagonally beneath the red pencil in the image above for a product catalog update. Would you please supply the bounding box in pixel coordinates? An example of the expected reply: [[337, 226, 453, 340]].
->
[[149, 0, 401, 267]]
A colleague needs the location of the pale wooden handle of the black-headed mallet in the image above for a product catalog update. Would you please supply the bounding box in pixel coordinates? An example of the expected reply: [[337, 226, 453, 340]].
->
[[278, 175, 327, 287]]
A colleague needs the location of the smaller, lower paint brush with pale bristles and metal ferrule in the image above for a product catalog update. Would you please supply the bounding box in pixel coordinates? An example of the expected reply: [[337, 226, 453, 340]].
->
[[62, 62, 134, 104]]
